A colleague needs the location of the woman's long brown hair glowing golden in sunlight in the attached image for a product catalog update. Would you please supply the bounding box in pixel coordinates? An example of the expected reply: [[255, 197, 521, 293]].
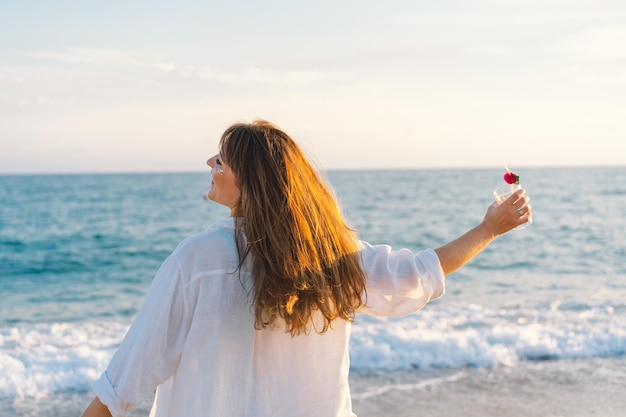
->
[[220, 120, 365, 336]]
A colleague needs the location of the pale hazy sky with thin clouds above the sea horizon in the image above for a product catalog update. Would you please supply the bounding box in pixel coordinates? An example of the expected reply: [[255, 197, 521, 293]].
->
[[0, 0, 626, 174]]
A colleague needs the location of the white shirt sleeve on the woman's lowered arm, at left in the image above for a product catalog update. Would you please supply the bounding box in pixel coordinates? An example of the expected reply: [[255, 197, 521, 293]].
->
[[93, 250, 190, 417]]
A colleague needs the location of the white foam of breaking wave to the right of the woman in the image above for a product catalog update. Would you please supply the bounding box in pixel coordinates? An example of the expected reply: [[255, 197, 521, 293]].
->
[[351, 305, 626, 370]]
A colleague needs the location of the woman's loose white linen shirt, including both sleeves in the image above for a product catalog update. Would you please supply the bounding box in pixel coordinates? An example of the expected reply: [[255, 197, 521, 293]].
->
[[93, 218, 445, 417]]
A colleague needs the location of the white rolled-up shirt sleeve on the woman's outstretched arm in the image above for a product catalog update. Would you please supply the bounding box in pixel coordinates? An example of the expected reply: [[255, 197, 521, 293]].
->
[[358, 242, 445, 317]]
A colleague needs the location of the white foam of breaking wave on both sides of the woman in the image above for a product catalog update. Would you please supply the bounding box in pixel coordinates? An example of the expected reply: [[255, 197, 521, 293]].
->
[[0, 305, 626, 399]]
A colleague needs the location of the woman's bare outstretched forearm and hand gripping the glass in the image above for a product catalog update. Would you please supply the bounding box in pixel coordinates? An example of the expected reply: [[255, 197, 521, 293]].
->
[[435, 190, 532, 275]]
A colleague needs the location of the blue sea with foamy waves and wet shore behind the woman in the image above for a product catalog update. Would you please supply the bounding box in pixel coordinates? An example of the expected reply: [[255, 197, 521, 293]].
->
[[0, 166, 626, 417]]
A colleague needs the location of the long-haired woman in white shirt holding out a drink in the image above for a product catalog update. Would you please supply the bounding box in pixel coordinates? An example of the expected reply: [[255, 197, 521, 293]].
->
[[83, 121, 531, 417]]
